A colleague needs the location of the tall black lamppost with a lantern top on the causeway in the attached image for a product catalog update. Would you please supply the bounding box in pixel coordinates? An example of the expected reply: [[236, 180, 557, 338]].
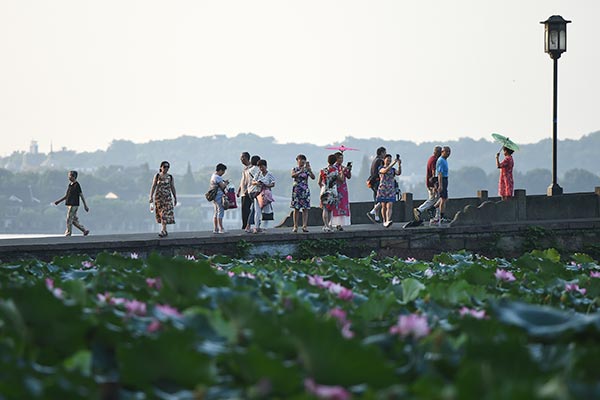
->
[[540, 15, 571, 196]]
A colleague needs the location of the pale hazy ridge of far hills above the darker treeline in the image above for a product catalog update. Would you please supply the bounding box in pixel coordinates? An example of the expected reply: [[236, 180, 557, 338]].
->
[[0, 131, 600, 176]]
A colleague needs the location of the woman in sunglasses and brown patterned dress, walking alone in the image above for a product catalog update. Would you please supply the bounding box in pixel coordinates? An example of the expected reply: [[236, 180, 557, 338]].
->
[[150, 161, 177, 237]]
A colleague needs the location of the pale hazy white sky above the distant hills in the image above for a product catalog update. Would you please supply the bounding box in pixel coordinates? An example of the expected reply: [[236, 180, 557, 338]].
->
[[0, 0, 600, 155]]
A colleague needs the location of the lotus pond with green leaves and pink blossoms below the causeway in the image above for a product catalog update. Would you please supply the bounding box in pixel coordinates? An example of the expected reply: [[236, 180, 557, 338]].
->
[[0, 249, 600, 399]]
